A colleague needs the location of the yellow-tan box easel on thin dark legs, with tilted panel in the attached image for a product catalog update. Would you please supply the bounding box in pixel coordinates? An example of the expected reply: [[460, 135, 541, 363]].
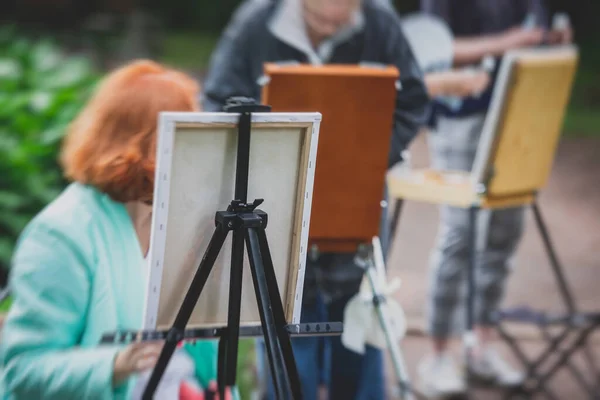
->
[[387, 46, 600, 394]]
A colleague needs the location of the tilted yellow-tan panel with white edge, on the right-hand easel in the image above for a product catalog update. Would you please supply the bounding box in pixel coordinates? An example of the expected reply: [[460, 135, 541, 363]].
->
[[472, 46, 578, 197]]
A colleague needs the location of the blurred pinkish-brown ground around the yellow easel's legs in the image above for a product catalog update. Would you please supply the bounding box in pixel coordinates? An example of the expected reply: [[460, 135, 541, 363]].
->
[[388, 135, 600, 399]]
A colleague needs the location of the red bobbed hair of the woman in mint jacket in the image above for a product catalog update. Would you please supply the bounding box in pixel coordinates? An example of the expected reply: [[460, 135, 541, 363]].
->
[[61, 61, 199, 203]]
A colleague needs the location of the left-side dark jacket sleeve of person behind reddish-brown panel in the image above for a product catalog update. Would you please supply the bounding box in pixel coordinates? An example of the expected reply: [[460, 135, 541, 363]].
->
[[201, 1, 258, 112]]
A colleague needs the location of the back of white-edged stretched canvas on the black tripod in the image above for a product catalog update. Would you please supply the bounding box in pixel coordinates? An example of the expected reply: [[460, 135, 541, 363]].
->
[[144, 113, 320, 329]]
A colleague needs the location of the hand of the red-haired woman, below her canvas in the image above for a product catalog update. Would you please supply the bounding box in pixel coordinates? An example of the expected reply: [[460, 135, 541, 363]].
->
[[113, 342, 164, 387]]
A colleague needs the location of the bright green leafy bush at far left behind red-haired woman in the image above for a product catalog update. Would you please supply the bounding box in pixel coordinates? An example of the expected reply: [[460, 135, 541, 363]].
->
[[0, 27, 97, 268]]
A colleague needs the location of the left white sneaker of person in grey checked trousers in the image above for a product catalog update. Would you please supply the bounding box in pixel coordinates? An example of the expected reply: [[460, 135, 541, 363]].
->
[[418, 354, 467, 398]]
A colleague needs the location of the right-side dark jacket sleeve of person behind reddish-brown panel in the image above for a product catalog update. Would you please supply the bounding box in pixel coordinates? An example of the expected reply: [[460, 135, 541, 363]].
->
[[382, 15, 430, 164]]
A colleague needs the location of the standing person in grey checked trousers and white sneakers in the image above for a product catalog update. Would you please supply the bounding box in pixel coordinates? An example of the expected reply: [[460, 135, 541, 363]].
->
[[419, 0, 571, 396]]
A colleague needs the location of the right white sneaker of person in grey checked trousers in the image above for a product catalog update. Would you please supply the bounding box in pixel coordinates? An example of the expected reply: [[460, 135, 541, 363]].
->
[[470, 348, 525, 387]]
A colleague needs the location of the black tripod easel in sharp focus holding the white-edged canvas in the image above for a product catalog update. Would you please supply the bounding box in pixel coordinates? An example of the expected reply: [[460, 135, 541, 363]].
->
[[139, 98, 342, 400]]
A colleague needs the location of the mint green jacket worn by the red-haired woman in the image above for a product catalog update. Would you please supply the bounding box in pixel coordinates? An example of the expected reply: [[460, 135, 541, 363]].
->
[[0, 184, 217, 400]]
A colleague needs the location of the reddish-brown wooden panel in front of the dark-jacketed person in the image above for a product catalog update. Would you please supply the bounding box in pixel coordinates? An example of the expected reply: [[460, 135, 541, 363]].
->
[[262, 64, 399, 252]]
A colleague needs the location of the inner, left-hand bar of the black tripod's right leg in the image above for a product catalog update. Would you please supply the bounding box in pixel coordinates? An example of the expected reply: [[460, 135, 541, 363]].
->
[[246, 228, 291, 399]]
